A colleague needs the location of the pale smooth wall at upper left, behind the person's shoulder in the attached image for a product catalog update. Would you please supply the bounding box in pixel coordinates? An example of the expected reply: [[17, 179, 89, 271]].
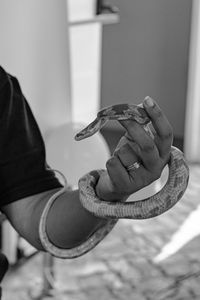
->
[[0, 0, 71, 133]]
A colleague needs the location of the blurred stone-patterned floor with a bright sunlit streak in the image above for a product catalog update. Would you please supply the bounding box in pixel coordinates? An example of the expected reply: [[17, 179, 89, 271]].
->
[[2, 132, 200, 300]]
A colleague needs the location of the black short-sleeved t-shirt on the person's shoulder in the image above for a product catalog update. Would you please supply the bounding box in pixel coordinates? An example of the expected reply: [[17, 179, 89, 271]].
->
[[0, 67, 62, 207]]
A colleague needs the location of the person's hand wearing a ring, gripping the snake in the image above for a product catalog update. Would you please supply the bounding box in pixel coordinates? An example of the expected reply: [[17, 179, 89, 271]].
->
[[96, 97, 173, 201]]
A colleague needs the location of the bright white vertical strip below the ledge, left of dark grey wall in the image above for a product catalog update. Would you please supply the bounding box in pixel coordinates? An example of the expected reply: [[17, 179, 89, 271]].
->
[[69, 22, 102, 123]]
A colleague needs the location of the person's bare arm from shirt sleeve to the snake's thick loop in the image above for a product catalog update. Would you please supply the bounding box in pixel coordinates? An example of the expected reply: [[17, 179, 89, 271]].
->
[[3, 190, 106, 250]]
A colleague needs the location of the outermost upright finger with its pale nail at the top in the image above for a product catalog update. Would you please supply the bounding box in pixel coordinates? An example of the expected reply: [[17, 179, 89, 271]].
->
[[143, 97, 173, 158]]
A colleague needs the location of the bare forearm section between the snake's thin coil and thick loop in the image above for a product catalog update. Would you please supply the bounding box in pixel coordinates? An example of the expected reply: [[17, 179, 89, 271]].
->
[[47, 190, 106, 248]]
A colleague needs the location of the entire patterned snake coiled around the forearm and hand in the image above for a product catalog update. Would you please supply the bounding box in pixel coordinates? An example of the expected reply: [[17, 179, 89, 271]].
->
[[39, 104, 189, 258]]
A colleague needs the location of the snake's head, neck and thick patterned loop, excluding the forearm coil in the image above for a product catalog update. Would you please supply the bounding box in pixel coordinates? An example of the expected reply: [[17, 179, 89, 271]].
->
[[75, 104, 189, 219]]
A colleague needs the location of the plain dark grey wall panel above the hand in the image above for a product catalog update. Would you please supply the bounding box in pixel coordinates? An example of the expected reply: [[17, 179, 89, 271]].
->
[[101, 0, 192, 137]]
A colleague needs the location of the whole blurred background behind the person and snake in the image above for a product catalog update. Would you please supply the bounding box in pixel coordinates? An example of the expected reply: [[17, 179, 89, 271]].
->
[[0, 0, 200, 300]]
